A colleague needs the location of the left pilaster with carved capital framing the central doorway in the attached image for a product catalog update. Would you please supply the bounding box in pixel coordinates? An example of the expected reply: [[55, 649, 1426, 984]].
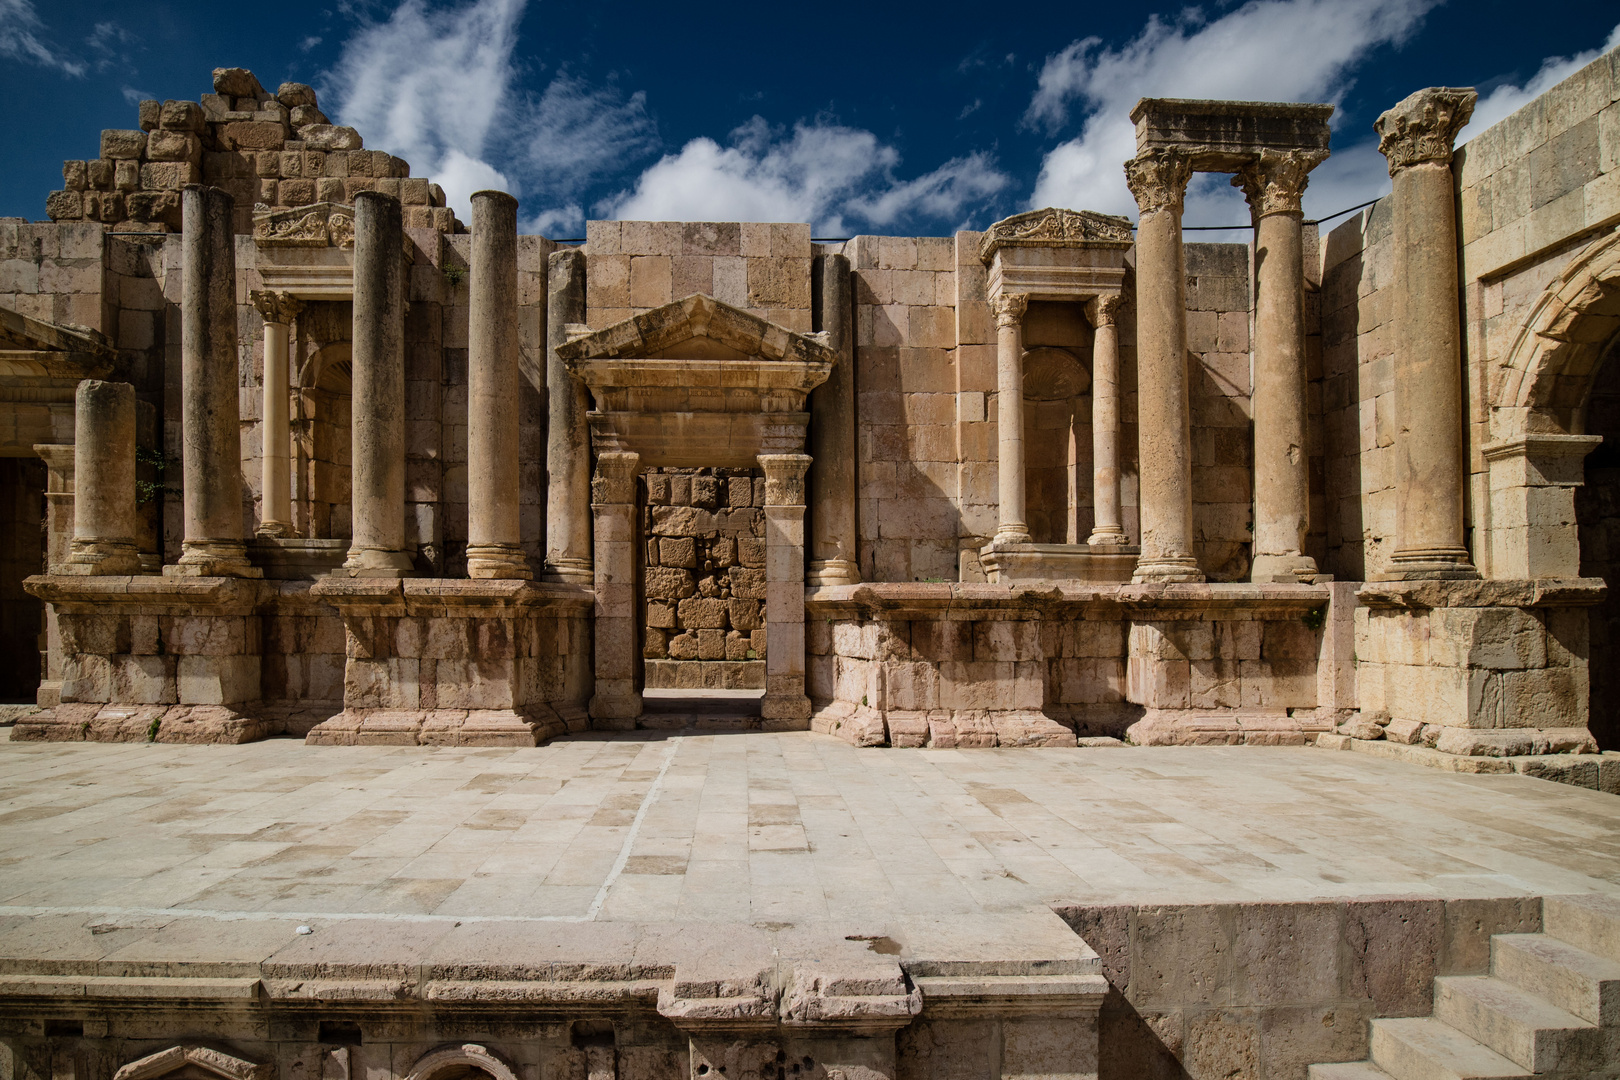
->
[[590, 450, 643, 729]]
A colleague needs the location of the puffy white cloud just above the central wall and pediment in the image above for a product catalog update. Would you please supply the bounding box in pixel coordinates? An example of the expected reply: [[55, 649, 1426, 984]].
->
[[603, 117, 1008, 233]]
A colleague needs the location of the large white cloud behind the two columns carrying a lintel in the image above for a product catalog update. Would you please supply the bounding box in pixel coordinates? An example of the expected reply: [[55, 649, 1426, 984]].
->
[[1025, 0, 1437, 225]]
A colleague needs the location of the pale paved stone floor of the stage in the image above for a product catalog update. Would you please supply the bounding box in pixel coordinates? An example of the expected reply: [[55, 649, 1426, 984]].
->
[[0, 733, 1620, 925]]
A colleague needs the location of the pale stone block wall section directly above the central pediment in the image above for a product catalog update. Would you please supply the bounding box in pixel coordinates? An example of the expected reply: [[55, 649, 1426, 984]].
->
[[585, 222, 816, 334]]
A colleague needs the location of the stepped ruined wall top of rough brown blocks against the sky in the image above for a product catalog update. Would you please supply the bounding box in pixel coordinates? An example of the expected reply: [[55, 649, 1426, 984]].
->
[[45, 68, 465, 233]]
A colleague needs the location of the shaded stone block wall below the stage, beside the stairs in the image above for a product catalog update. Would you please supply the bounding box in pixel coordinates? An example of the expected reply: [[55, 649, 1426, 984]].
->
[[1055, 897, 1541, 1080]]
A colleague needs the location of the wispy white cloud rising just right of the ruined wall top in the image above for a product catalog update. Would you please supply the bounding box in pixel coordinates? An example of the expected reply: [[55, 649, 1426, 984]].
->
[[325, 0, 523, 220]]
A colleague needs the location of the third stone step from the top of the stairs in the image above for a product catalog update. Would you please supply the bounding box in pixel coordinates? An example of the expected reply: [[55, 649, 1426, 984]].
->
[[1434, 975, 1597, 1072]]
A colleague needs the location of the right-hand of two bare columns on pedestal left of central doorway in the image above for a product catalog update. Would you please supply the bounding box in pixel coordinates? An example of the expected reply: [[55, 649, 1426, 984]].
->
[[467, 191, 535, 578]]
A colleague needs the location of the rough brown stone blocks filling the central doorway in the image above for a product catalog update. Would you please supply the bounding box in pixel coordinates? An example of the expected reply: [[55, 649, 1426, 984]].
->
[[642, 468, 765, 690]]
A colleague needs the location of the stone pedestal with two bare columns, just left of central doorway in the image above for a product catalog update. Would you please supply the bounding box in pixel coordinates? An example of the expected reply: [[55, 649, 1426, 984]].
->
[[306, 576, 591, 746]]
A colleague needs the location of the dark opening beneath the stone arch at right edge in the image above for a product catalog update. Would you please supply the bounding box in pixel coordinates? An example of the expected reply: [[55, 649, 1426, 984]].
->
[[1575, 338, 1620, 750]]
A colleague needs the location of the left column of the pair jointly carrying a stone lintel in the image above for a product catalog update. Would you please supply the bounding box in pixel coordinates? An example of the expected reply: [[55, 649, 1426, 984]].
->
[[1124, 151, 1204, 581]]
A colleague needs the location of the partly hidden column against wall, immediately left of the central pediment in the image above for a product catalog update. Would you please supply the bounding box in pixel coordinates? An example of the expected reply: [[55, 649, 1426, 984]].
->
[[546, 248, 596, 582]]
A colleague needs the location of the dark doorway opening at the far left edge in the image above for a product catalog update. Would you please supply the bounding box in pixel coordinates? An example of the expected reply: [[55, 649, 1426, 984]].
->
[[0, 458, 45, 703]]
